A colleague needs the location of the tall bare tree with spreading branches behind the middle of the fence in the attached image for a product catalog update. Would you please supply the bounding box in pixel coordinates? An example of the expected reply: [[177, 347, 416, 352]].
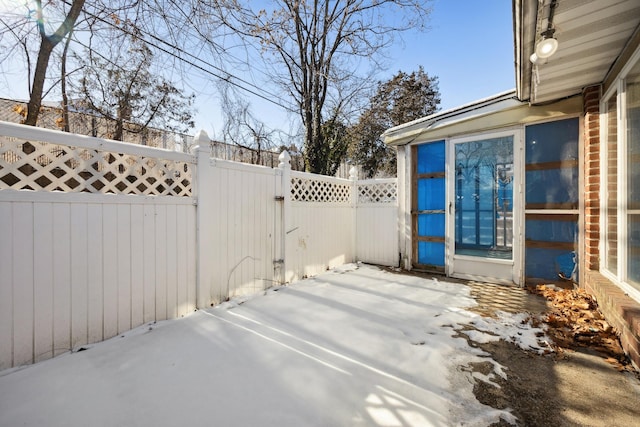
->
[[216, 0, 430, 172]]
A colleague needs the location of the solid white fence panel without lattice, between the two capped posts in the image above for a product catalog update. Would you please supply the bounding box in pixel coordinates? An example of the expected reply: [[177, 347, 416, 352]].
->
[[197, 155, 280, 307]]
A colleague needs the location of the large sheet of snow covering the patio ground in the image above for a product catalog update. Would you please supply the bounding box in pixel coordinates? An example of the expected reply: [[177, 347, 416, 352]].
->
[[0, 264, 552, 426]]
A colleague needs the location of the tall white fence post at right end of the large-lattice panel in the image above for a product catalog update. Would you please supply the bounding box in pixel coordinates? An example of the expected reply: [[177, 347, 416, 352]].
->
[[193, 130, 215, 309]]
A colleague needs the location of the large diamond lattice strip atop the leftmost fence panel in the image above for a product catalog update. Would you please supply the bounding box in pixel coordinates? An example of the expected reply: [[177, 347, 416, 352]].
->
[[0, 136, 192, 197]]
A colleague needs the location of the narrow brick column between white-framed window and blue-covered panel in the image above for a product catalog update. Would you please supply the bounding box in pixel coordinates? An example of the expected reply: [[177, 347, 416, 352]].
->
[[582, 86, 600, 270]]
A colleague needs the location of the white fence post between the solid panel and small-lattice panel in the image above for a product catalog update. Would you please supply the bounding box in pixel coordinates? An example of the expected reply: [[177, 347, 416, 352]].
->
[[275, 150, 293, 284]]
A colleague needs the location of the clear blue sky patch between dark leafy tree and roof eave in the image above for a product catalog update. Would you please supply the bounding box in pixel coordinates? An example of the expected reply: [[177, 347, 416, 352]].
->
[[400, 0, 515, 110]]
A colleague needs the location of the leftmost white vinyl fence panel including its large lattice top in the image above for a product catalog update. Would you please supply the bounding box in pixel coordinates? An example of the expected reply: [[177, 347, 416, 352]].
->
[[0, 124, 196, 368]]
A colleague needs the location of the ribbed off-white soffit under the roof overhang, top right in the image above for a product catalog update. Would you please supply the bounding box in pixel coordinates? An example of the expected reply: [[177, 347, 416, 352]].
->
[[514, 0, 640, 104]]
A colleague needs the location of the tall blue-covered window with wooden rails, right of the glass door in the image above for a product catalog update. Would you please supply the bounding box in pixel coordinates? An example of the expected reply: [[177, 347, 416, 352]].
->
[[525, 118, 579, 283]]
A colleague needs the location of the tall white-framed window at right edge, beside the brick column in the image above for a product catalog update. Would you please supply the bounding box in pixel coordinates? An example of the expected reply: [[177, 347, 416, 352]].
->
[[601, 51, 640, 298]]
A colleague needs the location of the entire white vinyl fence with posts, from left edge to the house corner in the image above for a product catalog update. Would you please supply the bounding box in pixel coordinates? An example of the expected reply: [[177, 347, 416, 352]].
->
[[0, 122, 398, 370]]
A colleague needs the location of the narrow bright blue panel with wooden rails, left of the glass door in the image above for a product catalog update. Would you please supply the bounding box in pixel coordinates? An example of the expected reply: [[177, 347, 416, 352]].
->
[[412, 141, 446, 272]]
